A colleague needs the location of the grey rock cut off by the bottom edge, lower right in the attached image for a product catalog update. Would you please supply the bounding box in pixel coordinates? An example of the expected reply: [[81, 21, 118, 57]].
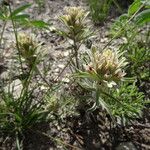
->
[[116, 142, 137, 150]]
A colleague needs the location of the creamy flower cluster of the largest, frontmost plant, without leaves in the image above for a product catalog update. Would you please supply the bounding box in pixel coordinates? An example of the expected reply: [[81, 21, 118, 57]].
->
[[88, 49, 127, 85]]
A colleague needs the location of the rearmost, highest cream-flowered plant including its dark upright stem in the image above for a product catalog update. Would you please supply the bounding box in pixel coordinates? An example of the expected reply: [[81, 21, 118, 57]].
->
[[59, 7, 93, 69]]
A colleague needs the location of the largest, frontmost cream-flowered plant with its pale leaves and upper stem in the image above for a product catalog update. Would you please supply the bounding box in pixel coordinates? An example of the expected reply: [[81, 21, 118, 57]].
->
[[74, 47, 127, 112]]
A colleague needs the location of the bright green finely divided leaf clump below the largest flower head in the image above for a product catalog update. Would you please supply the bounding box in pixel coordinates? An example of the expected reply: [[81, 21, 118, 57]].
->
[[107, 82, 145, 123]]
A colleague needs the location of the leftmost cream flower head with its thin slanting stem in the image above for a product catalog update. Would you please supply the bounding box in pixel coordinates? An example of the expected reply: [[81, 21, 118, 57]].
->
[[18, 33, 51, 87]]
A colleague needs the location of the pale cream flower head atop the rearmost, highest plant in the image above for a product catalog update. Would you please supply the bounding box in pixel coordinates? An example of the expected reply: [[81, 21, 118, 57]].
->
[[60, 7, 91, 42]]
